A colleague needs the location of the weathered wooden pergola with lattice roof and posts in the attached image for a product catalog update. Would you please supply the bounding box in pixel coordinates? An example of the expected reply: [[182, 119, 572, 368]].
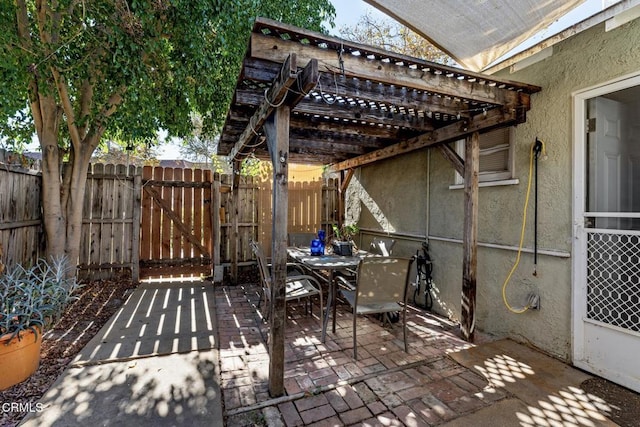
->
[[218, 18, 540, 396]]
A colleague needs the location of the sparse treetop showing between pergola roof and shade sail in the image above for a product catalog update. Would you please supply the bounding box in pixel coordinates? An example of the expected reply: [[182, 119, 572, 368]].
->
[[340, 13, 454, 65]]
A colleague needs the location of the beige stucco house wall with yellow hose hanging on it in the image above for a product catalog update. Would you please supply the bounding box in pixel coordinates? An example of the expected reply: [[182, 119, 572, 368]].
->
[[349, 20, 640, 360]]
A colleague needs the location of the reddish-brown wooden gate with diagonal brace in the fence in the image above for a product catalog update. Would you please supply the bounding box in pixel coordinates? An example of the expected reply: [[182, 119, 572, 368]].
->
[[140, 166, 213, 278]]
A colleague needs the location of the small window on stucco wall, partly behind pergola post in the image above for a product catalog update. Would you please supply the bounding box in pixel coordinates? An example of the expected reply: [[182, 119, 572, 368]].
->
[[455, 127, 514, 185]]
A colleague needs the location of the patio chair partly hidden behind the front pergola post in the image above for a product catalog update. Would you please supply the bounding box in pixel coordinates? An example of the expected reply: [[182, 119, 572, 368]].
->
[[251, 242, 323, 320]]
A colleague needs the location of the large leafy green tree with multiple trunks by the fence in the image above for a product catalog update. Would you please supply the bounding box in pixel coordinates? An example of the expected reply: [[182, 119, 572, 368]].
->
[[0, 0, 335, 270]]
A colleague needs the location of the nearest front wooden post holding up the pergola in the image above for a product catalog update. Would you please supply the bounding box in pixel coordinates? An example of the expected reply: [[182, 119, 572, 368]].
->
[[264, 105, 290, 397]]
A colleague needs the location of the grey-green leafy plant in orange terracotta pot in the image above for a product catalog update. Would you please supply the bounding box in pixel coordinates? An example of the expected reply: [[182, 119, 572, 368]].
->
[[0, 258, 79, 390]]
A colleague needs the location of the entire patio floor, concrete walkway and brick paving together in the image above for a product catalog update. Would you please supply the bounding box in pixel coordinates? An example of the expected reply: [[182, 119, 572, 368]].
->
[[21, 281, 624, 427]]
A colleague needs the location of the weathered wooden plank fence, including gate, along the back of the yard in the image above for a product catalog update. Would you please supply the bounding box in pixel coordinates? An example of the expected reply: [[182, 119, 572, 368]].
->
[[0, 152, 338, 279]]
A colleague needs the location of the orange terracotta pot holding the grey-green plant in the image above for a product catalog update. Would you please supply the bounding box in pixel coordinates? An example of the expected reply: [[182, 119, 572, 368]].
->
[[0, 330, 42, 390]]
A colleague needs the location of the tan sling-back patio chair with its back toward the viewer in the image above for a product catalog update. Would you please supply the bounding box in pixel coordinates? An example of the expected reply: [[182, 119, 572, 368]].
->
[[333, 257, 413, 360]]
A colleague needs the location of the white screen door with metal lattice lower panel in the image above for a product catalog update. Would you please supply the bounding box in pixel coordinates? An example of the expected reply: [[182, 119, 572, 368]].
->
[[573, 77, 640, 391]]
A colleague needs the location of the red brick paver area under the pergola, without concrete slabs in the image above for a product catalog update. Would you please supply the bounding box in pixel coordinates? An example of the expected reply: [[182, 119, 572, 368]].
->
[[215, 284, 507, 426]]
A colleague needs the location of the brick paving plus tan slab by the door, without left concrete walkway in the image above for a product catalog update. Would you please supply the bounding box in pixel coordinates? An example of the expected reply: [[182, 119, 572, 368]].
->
[[215, 284, 616, 426]]
